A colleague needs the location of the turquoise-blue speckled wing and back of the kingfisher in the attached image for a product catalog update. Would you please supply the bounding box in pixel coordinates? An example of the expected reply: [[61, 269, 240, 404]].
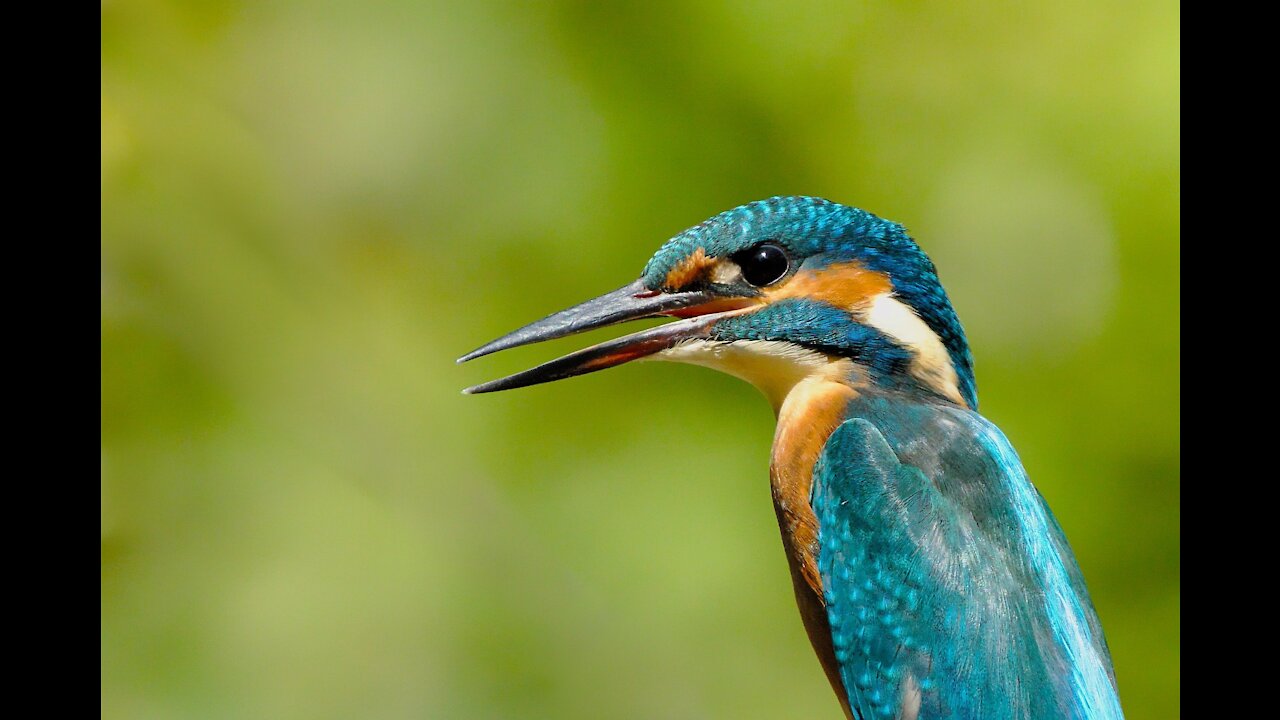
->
[[812, 398, 1123, 720]]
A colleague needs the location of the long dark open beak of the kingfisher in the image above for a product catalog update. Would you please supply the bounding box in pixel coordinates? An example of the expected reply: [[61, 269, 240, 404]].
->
[[458, 275, 753, 395]]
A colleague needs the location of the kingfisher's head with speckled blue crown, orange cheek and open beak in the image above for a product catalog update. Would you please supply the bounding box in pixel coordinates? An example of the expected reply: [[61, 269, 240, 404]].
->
[[458, 197, 978, 409]]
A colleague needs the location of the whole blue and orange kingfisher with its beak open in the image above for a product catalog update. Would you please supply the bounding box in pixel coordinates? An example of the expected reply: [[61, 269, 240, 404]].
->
[[458, 196, 1123, 720]]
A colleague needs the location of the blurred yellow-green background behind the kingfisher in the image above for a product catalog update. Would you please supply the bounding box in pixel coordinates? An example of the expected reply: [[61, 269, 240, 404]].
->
[[101, 0, 1180, 720]]
